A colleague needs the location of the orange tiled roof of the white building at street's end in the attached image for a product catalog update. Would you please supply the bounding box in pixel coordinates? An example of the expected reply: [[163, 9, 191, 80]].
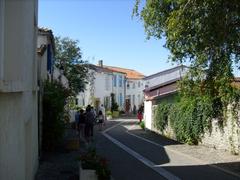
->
[[104, 66, 145, 79]]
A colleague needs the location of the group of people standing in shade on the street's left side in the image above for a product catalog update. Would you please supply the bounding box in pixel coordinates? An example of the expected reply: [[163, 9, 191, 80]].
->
[[75, 105, 105, 141]]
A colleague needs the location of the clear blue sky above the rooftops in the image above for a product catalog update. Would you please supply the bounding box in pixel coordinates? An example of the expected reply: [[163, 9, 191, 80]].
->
[[38, 0, 174, 75]]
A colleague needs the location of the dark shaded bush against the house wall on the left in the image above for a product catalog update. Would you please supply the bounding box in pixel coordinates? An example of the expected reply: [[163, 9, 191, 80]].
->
[[42, 81, 69, 151]]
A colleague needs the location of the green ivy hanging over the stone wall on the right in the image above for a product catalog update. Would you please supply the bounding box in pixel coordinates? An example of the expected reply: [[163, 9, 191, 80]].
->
[[154, 79, 239, 144]]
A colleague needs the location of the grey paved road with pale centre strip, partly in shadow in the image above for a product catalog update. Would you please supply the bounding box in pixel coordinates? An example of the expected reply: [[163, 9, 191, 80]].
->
[[96, 120, 239, 180]]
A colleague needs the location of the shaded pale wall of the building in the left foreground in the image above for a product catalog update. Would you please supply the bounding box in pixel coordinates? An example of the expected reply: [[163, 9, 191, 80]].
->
[[0, 0, 38, 180]]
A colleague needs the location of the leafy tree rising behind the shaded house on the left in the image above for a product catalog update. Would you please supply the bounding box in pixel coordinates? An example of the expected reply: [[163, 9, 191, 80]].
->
[[55, 37, 88, 95]]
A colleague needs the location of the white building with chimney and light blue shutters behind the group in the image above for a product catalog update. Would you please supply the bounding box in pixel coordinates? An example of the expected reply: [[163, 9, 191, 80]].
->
[[77, 61, 125, 110]]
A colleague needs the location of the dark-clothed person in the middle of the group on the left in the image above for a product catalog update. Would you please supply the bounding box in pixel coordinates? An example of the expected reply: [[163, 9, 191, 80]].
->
[[85, 105, 95, 142]]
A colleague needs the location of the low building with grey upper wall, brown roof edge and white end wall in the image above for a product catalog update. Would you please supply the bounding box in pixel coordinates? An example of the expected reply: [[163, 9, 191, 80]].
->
[[144, 66, 188, 129]]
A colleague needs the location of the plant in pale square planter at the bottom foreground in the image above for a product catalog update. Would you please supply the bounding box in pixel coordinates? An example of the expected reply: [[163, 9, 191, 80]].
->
[[79, 149, 111, 180]]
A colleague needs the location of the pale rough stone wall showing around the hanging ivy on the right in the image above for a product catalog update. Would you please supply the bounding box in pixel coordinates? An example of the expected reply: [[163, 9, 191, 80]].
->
[[149, 106, 240, 154]]
